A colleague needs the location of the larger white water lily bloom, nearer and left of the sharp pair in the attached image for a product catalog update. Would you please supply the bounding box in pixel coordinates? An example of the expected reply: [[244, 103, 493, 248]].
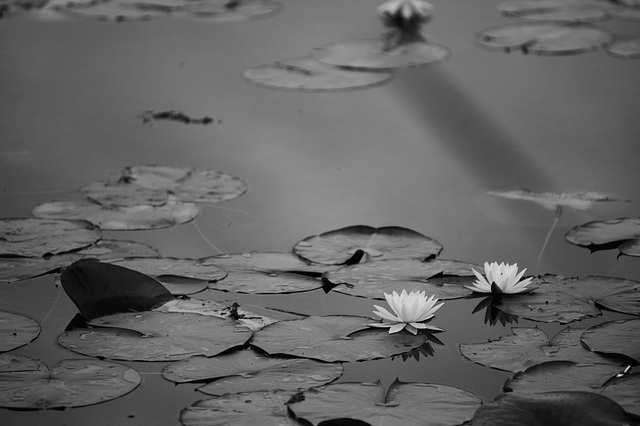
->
[[369, 290, 444, 334]]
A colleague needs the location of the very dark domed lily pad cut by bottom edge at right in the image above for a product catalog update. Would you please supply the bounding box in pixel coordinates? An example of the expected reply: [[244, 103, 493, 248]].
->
[[465, 391, 631, 426]]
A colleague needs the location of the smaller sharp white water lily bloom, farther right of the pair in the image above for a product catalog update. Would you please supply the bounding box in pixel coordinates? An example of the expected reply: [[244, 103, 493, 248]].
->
[[465, 262, 533, 294]]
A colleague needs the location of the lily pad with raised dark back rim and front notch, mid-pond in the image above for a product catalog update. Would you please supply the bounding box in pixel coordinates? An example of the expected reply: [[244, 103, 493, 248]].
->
[[293, 225, 442, 265]]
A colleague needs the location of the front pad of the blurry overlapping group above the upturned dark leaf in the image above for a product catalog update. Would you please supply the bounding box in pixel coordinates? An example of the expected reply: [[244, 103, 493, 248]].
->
[[31, 196, 199, 231]]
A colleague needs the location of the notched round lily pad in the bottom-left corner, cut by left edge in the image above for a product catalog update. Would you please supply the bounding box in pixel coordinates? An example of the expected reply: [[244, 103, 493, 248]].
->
[[0, 354, 142, 410]]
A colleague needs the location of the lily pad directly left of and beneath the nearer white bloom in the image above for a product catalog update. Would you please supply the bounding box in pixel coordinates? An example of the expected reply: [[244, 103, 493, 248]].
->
[[251, 315, 426, 362]]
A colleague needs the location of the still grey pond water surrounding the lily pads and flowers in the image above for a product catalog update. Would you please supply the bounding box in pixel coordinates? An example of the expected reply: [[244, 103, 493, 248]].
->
[[0, 0, 640, 426]]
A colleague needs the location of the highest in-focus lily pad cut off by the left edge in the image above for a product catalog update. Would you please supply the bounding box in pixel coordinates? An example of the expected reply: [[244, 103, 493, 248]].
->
[[0, 218, 101, 257]]
